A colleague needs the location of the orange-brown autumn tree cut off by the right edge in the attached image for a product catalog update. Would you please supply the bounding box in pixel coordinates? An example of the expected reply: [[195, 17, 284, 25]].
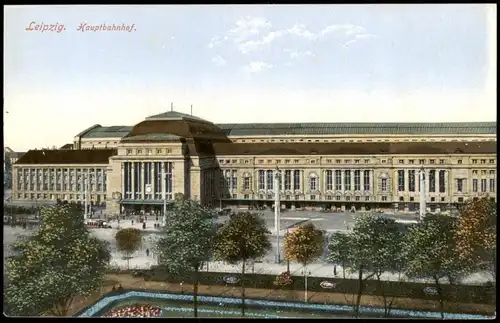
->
[[456, 197, 497, 280]]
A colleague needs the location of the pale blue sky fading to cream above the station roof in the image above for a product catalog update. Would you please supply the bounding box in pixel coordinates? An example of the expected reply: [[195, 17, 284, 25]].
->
[[4, 5, 496, 150]]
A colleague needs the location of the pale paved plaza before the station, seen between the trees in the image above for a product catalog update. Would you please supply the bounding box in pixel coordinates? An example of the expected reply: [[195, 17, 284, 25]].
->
[[4, 211, 491, 284]]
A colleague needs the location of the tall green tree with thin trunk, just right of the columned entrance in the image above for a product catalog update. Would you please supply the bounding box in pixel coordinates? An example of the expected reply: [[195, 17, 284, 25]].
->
[[156, 197, 217, 317]]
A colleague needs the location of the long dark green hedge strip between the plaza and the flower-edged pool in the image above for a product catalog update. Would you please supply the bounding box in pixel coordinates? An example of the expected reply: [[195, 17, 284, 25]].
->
[[106, 266, 496, 305]]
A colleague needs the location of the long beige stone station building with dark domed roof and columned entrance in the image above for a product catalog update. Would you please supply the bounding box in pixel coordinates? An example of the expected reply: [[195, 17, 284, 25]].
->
[[12, 111, 497, 214]]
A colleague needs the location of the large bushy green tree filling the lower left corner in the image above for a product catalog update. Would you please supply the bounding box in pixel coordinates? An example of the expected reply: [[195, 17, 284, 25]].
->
[[4, 205, 110, 316]]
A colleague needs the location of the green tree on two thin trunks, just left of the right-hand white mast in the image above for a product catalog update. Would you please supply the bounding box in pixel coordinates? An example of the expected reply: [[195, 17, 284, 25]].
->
[[351, 215, 404, 317]]
